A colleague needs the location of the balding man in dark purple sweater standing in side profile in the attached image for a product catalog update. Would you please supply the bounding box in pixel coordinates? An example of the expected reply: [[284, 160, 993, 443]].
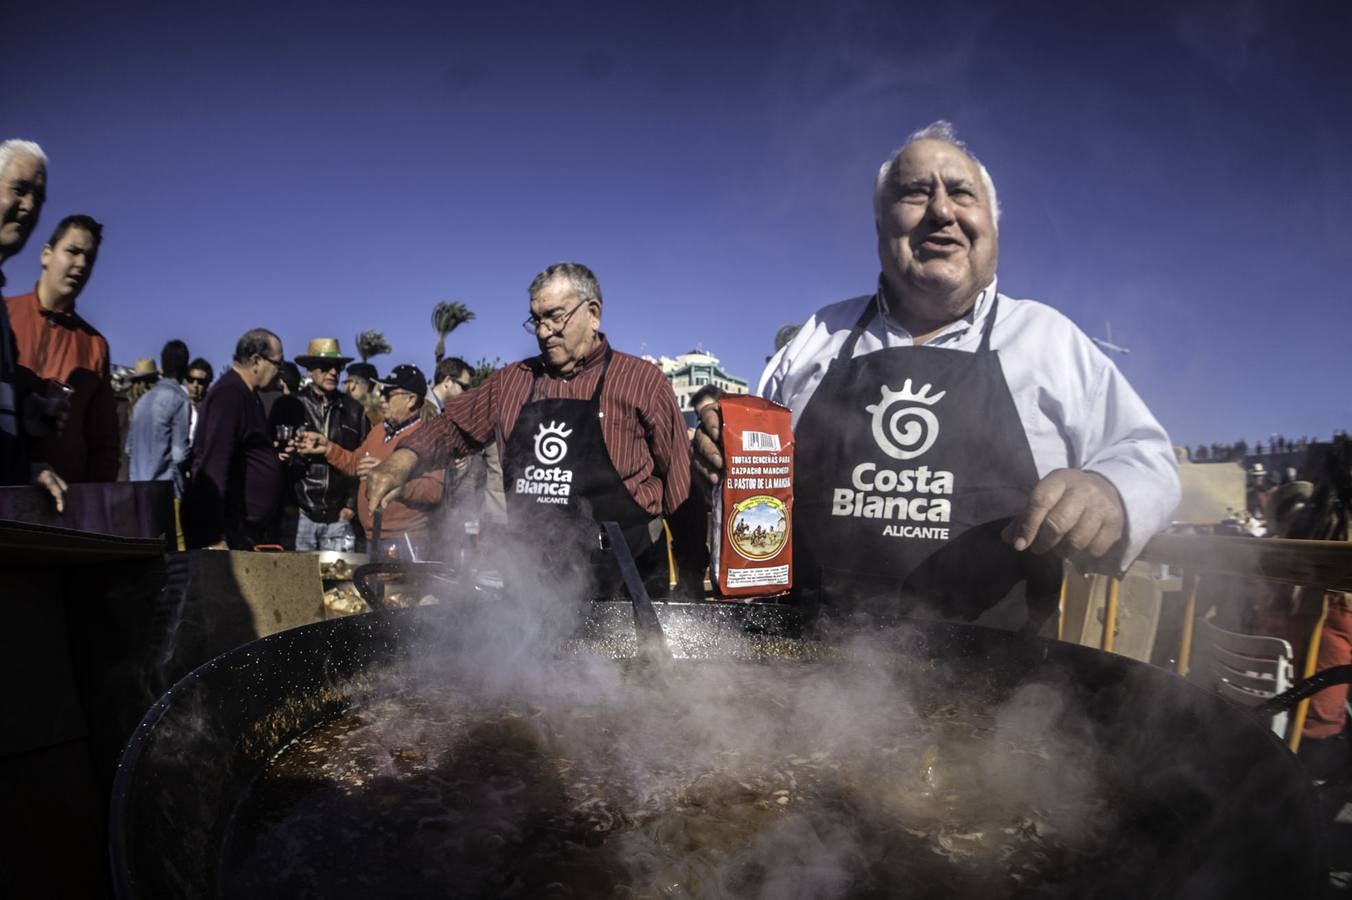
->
[[184, 328, 284, 550]]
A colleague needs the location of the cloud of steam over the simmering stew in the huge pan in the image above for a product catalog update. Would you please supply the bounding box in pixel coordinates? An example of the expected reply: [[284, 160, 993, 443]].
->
[[219, 531, 1130, 899]]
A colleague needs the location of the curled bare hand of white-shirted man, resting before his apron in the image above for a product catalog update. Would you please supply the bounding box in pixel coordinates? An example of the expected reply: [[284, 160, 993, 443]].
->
[[1000, 469, 1126, 561]]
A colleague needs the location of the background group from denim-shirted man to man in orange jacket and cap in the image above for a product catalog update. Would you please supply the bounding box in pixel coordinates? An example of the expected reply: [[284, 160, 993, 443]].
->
[[116, 328, 485, 555]]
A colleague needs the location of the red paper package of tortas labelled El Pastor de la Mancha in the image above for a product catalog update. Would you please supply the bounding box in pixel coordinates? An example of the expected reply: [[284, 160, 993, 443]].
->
[[708, 395, 794, 600]]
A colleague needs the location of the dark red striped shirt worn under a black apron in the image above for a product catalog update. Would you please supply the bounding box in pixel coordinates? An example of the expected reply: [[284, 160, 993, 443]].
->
[[400, 335, 690, 515]]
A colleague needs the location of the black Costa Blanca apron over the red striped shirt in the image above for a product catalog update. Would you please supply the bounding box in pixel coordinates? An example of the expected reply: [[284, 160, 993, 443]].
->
[[503, 347, 665, 596]]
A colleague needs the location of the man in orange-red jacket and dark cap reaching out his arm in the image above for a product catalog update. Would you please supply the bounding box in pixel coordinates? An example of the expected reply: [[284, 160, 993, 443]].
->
[[296, 365, 446, 559]]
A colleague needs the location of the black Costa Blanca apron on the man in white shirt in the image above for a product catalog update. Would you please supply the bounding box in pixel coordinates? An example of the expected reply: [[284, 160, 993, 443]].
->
[[794, 290, 1061, 628]]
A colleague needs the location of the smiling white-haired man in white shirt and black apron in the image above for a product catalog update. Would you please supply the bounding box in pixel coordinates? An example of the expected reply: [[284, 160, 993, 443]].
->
[[694, 122, 1179, 628]]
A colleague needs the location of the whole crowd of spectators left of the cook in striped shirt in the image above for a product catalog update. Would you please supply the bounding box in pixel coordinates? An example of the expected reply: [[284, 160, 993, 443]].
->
[[0, 141, 494, 550]]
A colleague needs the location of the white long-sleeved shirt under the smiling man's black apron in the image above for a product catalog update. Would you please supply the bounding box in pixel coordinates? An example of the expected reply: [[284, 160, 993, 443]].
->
[[756, 281, 1179, 569]]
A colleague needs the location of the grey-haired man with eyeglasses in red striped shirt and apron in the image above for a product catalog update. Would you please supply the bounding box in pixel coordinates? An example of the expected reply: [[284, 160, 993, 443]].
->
[[369, 262, 690, 593]]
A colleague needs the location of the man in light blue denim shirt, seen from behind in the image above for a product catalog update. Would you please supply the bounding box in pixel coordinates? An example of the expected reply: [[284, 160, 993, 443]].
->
[[127, 341, 192, 497]]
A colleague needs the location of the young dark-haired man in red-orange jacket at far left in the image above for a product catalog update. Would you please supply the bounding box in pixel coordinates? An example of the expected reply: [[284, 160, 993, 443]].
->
[[5, 215, 122, 482]]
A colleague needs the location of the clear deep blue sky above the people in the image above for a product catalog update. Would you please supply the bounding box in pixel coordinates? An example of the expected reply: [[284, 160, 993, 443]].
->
[[0, 0, 1352, 443]]
